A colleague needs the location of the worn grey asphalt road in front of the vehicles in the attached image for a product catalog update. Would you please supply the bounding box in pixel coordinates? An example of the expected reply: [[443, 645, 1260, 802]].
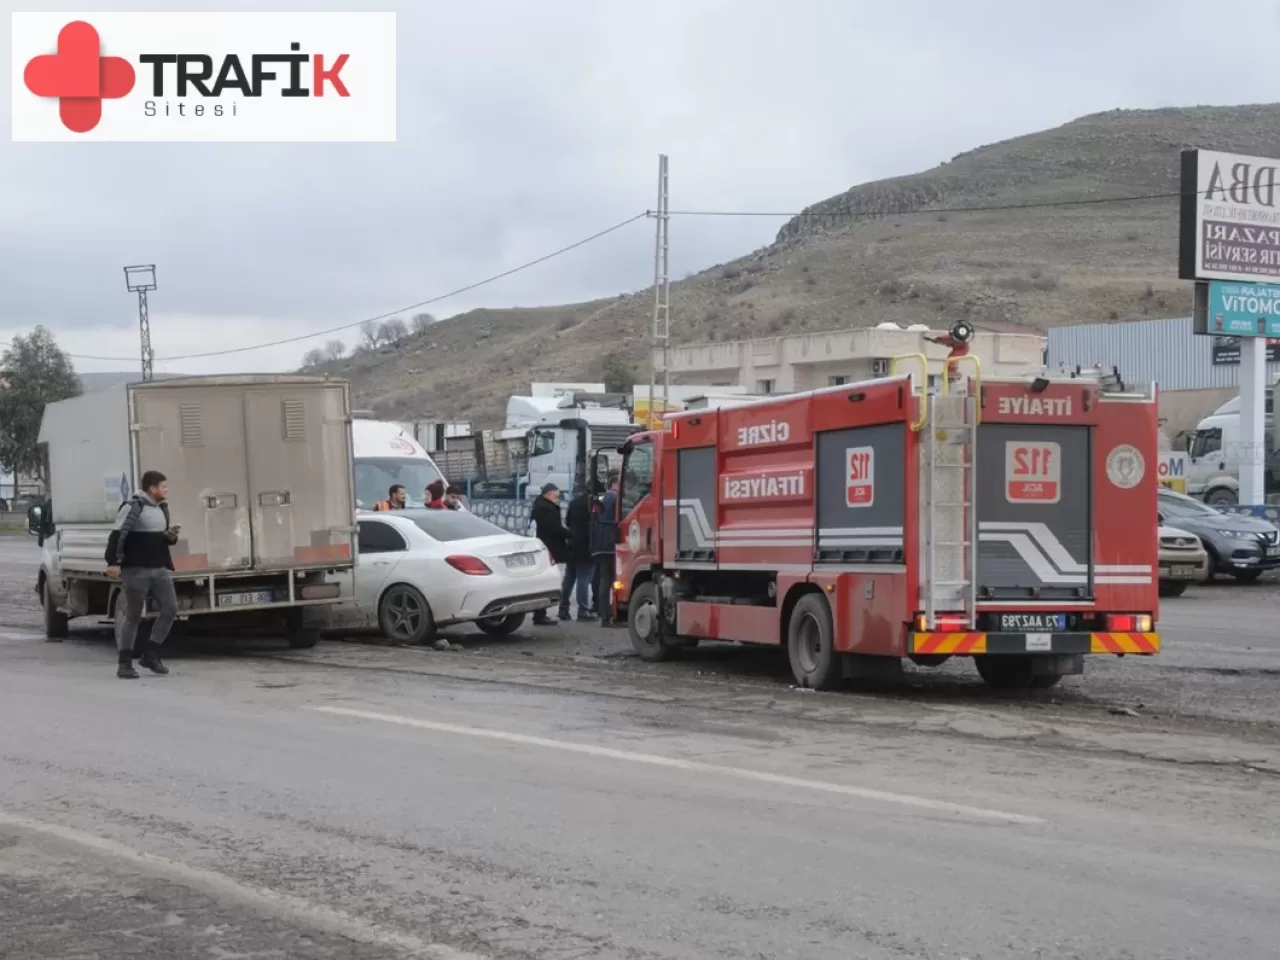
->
[[0, 540, 1280, 960]]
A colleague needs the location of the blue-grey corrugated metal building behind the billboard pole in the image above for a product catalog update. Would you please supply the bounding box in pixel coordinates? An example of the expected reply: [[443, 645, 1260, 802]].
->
[[1044, 316, 1280, 435]]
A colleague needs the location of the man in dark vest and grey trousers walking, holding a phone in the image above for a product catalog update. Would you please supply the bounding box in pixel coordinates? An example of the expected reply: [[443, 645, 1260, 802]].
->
[[105, 470, 182, 680]]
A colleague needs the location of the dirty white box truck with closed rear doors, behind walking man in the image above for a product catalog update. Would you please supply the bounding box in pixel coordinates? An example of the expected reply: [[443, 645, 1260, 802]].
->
[[29, 375, 356, 646]]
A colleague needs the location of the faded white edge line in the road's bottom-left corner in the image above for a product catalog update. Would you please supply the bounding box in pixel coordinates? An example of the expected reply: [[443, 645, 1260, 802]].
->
[[0, 810, 488, 960]]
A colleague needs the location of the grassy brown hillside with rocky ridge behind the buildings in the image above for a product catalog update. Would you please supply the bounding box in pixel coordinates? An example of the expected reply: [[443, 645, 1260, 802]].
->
[[309, 105, 1280, 425]]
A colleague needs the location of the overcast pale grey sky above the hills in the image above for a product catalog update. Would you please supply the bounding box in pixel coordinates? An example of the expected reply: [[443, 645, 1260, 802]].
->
[[0, 0, 1280, 372]]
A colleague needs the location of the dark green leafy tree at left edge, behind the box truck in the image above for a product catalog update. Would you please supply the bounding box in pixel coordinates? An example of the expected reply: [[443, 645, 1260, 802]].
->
[[0, 326, 83, 481]]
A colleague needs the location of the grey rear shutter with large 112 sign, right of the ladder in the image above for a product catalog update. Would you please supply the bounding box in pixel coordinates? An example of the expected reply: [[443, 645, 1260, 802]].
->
[[977, 422, 1093, 603]]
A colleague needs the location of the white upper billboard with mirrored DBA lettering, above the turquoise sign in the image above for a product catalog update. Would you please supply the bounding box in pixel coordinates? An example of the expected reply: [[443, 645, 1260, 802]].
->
[[1178, 150, 1280, 283]]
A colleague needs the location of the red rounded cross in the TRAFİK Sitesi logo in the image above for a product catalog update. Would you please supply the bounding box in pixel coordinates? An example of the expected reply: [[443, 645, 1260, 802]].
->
[[22, 20, 134, 133]]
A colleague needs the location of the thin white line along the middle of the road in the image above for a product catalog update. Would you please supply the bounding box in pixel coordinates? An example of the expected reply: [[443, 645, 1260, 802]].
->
[[312, 707, 1044, 823]]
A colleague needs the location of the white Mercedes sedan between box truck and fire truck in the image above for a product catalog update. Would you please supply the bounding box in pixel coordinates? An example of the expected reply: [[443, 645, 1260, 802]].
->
[[353, 509, 561, 644]]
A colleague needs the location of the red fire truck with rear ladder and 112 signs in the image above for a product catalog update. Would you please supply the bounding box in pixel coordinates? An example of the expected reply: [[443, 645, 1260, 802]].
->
[[599, 330, 1160, 690]]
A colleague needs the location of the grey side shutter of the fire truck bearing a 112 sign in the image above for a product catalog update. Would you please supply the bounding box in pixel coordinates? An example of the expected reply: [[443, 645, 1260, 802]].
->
[[815, 422, 906, 563]]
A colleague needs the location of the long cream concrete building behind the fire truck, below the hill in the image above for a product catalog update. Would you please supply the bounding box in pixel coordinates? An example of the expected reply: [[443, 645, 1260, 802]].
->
[[654, 328, 1044, 394]]
